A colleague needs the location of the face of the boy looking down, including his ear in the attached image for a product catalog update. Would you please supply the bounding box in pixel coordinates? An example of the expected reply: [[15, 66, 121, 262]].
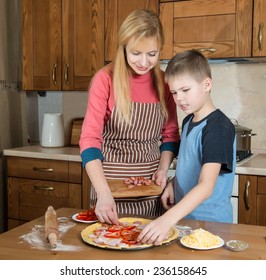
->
[[168, 74, 212, 114]]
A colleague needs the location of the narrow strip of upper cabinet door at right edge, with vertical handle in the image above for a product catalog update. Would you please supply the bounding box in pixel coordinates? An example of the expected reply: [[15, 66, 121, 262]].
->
[[253, 0, 266, 57]]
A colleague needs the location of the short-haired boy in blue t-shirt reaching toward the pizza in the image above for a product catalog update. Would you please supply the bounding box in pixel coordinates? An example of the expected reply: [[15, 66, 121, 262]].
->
[[138, 50, 236, 245]]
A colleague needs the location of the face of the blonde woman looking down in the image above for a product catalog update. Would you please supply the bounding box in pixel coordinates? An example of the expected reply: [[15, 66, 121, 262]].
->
[[126, 37, 159, 75]]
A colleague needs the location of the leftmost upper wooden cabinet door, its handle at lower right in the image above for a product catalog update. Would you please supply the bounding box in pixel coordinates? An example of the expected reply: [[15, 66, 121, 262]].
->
[[22, 0, 61, 90]]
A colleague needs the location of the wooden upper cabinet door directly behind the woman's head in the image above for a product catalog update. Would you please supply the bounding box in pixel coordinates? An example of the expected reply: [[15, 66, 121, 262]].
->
[[104, 0, 159, 61]]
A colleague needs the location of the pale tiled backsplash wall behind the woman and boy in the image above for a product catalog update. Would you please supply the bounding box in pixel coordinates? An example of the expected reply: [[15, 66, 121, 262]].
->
[[32, 63, 266, 152]]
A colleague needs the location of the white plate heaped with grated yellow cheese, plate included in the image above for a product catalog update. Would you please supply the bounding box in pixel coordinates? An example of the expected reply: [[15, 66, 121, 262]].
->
[[180, 228, 224, 250]]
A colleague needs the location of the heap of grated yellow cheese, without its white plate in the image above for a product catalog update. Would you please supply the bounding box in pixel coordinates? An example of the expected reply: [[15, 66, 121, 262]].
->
[[182, 228, 221, 248]]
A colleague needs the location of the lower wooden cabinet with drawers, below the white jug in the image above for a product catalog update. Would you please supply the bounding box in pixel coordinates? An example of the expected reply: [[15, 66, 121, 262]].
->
[[7, 157, 82, 229]]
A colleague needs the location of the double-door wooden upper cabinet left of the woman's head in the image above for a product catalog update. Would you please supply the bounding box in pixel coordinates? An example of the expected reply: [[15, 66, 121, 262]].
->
[[22, 0, 104, 91]]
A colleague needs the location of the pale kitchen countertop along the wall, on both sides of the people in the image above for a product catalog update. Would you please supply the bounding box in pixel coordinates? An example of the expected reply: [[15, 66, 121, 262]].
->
[[4, 145, 266, 176]]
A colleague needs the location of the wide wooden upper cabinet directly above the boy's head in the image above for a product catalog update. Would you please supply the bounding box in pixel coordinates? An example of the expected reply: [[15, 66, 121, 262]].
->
[[160, 0, 252, 59]]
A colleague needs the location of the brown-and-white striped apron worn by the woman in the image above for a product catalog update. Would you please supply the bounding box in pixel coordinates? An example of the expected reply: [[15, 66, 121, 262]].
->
[[90, 102, 164, 217]]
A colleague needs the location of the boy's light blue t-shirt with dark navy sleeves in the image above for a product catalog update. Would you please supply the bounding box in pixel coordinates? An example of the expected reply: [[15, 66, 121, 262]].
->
[[174, 109, 236, 223]]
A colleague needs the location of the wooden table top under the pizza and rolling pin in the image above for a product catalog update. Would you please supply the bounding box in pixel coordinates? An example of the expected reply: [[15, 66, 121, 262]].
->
[[0, 208, 266, 260]]
